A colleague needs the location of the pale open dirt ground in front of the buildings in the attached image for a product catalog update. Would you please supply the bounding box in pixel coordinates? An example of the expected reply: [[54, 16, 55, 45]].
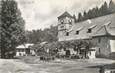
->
[[0, 57, 115, 73]]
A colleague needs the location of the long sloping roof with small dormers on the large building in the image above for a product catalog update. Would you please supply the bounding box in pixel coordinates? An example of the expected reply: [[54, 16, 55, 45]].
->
[[59, 13, 115, 41]]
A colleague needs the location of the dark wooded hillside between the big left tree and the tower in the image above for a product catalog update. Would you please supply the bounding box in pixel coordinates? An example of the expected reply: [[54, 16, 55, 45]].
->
[[26, 26, 58, 44]]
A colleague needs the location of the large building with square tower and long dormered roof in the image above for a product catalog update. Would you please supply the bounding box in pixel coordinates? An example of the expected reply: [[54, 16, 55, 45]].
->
[[58, 12, 115, 57]]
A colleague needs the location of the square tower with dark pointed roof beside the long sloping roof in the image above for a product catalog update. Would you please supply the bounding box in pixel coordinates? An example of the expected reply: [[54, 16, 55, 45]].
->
[[58, 11, 75, 38]]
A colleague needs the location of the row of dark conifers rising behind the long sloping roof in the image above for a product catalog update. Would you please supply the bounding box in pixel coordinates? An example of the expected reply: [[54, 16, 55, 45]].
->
[[77, 0, 115, 22]]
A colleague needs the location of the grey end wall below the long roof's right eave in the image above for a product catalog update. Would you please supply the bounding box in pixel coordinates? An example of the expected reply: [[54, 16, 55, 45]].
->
[[92, 37, 111, 57]]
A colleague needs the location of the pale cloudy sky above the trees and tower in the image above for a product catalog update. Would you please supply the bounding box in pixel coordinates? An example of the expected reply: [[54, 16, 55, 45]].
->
[[17, 0, 115, 30]]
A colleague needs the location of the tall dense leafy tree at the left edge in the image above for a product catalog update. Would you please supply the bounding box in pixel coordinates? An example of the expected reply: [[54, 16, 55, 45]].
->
[[0, 0, 25, 58]]
